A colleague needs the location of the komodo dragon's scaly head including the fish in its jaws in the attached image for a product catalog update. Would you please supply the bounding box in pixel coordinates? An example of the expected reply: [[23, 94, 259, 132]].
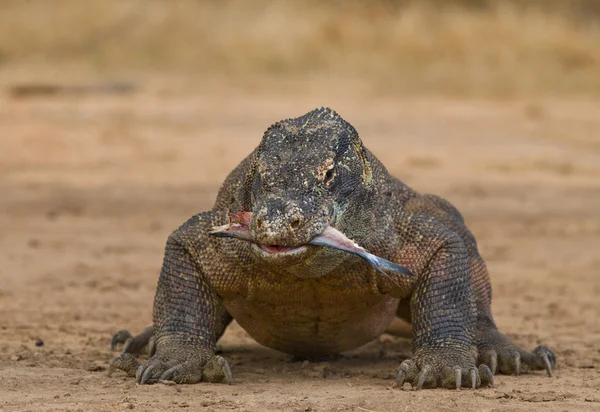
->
[[209, 108, 412, 278]]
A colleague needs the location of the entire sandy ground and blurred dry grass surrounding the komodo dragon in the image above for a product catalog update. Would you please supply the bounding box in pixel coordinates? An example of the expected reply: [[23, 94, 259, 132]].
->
[[0, 0, 600, 411]]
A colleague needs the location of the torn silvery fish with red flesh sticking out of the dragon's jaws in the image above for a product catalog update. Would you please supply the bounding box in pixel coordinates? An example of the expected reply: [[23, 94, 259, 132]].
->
[[209, 212, 412, 277]]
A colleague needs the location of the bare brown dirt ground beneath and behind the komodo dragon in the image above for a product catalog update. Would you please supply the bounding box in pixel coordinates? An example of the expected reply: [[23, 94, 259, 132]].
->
[[0, 85, 600, 412]]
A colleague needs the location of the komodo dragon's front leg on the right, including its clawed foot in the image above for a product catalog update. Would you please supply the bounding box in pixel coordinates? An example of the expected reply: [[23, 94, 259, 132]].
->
[[397, 231, 493, 389]]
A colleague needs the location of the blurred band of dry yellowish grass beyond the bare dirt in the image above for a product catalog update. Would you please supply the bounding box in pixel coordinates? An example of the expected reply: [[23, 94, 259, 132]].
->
[[0, 0, 600, 97]]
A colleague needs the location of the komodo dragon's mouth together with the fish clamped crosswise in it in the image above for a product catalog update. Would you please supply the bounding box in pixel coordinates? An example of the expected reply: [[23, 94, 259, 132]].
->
[[209, 212, 413, 277]]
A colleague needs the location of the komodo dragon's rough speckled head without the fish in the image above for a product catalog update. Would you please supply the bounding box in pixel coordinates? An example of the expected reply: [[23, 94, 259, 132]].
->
[[244, 108, 372, 272]]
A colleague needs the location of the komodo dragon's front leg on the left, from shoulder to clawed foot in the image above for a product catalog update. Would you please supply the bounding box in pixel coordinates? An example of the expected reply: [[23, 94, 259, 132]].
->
[[113, 213, 231, 384]]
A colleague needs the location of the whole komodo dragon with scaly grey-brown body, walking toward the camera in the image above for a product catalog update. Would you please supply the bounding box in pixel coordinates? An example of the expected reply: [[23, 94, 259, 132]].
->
[[109, 108, 556, 389]]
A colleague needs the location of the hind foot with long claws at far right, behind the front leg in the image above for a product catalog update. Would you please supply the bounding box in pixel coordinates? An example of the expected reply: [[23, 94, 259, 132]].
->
[[478, 330, 556, 377]]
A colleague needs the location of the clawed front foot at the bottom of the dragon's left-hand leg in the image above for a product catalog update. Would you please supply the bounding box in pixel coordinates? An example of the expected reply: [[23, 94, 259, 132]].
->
[[135, 349, 232, 385]]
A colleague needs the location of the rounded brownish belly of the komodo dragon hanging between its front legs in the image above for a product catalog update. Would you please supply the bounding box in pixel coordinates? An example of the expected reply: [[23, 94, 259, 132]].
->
[[224, 280, 399, 356]]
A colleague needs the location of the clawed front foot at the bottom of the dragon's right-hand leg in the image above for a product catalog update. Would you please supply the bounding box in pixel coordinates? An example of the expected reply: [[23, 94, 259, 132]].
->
[[396, 356, 494, 389]]
